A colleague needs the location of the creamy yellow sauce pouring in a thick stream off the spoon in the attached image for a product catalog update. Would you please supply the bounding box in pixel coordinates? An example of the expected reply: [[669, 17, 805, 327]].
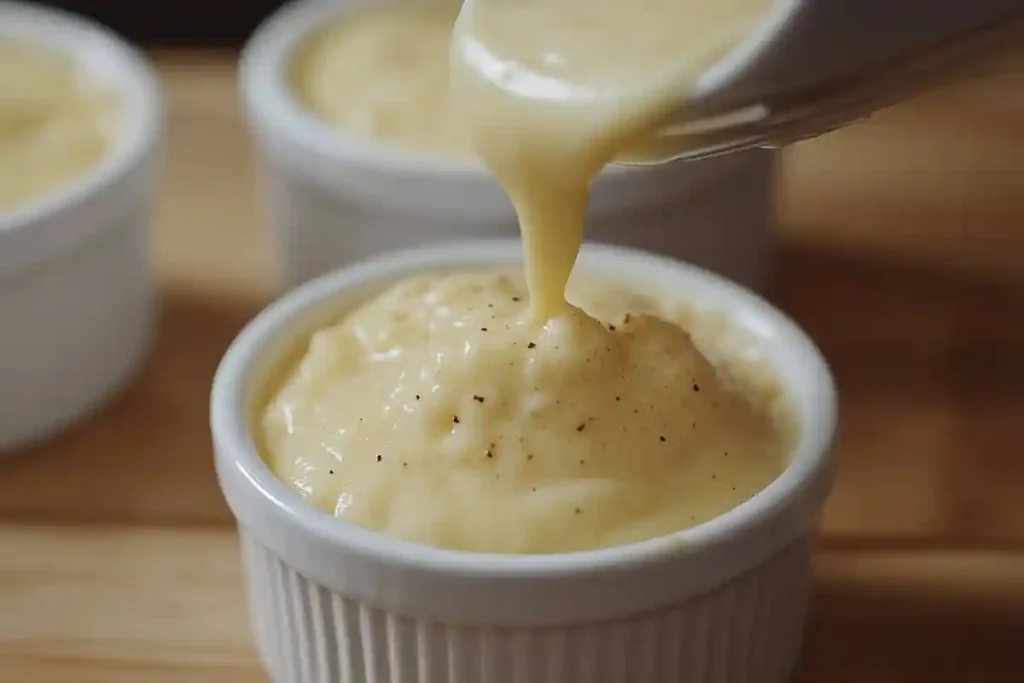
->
[[452, 0, 772, 321]]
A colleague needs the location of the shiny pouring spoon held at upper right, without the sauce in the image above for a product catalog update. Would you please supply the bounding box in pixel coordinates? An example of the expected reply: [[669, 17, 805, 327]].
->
[[616, 0, 1024, 165]]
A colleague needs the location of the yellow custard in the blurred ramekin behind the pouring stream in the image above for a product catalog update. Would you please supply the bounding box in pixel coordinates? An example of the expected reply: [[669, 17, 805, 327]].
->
[[290, 0, 472, 157]]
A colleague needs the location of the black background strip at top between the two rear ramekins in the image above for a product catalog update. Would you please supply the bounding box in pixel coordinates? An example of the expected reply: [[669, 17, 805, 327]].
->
[[40, 0, 285, 47]]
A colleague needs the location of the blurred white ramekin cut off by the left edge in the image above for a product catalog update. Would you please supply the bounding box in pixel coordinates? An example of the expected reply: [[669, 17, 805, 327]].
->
[[0, 2, 162, 455]]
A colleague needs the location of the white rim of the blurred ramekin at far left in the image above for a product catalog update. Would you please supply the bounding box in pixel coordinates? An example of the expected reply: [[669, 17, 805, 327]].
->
[[0, 0, 164, 233]]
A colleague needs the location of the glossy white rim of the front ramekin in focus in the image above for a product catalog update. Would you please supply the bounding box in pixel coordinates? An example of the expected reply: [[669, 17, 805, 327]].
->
[[211, 239, 838, 579]]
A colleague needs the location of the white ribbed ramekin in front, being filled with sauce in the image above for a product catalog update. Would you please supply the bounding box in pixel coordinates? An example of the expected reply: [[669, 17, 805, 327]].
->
[[211, 240, 837, 683]]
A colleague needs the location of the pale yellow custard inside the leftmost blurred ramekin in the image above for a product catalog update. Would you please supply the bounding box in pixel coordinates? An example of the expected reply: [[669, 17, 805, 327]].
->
[[0, 40, 111, 212]]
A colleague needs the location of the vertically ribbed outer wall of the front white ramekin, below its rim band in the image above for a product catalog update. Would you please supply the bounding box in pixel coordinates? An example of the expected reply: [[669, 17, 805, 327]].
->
[[240, 527, 811, 683]]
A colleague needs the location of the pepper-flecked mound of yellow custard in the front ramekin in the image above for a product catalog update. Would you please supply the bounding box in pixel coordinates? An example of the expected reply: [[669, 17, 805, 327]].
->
[[260, 271, 792, 553]]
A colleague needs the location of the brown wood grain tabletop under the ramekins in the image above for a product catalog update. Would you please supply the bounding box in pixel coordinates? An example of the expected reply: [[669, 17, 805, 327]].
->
[[0, 52, 1024, 683]]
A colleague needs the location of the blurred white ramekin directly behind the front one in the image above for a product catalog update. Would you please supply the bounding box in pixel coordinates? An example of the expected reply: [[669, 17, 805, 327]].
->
[[240, 0, 776, 289]]
